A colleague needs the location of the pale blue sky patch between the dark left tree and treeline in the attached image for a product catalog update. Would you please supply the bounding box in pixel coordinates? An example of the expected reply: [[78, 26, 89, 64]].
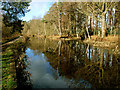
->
[[22, 0, 54, 21]]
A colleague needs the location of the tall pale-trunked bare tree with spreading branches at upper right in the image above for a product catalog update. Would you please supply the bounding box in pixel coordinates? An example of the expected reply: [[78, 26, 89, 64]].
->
[[78, 0, 116, 38]]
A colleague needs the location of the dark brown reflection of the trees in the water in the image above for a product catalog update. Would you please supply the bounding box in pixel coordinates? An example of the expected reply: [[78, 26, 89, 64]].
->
[[28, 38, 120, 88]]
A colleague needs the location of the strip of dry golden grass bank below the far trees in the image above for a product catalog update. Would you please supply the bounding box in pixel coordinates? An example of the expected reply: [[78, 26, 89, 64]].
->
[[24, 35, 118, 48]]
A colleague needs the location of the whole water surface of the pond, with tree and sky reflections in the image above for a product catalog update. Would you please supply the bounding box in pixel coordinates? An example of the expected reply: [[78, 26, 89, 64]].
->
[[1, 38, 120, 88]]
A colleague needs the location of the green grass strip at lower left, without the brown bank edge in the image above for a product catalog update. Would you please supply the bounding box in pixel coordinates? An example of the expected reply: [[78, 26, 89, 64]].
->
[[2, 44, 17, 89]]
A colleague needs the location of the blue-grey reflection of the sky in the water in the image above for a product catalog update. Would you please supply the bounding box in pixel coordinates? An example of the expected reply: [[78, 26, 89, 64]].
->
[[26, 48, 91, 88]]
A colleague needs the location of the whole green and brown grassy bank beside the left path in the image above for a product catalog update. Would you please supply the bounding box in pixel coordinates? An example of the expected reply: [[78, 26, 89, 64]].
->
[[2, 39, 25, 89]]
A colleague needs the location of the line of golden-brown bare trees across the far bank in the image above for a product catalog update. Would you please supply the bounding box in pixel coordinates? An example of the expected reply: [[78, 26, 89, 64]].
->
[[24, 1, 120, 39]]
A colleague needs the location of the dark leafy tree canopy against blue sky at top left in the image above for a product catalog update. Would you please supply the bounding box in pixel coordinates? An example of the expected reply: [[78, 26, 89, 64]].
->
[[2, 1, 30, 32]]
